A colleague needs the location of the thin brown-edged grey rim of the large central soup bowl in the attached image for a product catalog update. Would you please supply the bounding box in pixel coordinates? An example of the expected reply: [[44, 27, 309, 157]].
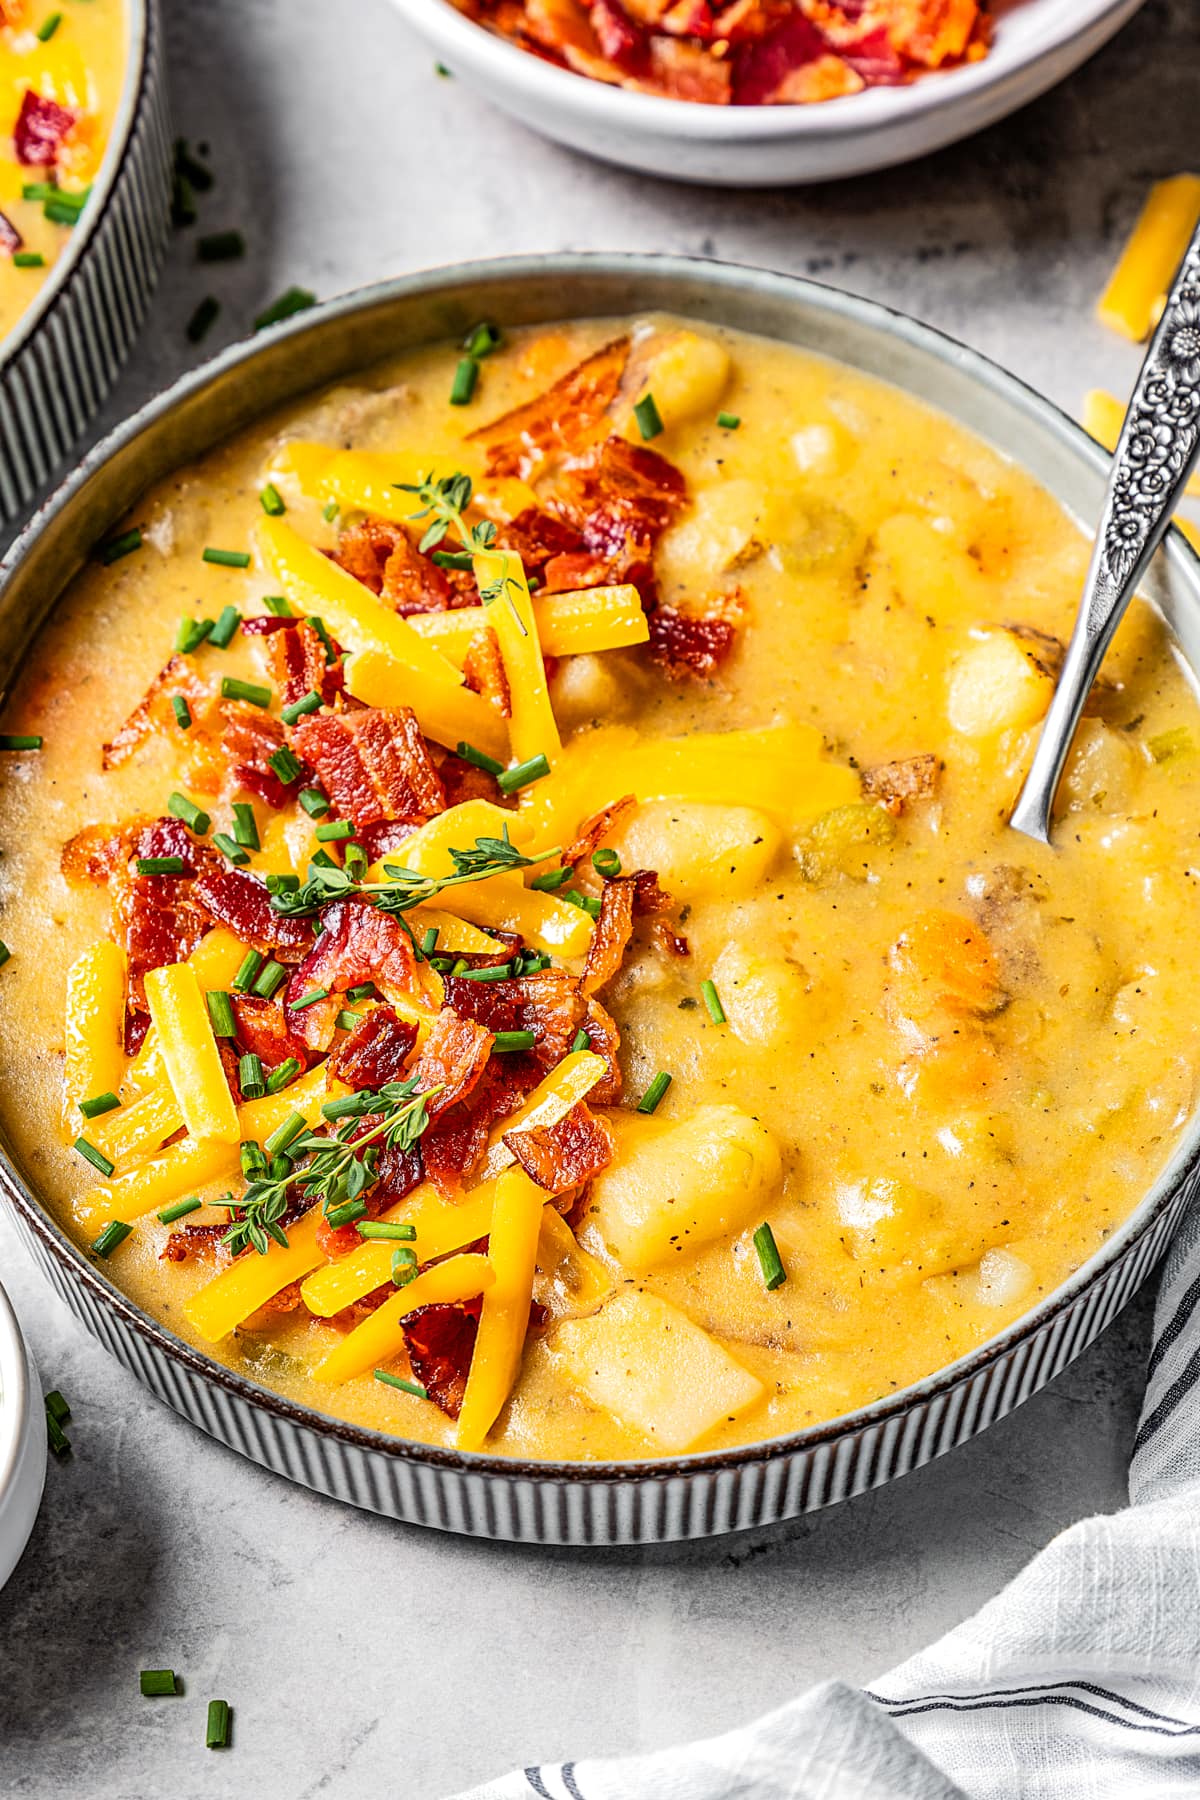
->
[[0, 252, 1200, 1485]]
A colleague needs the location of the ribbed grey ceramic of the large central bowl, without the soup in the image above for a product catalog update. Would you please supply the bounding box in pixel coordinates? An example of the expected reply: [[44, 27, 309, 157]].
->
[[0, 256, 1200, 1544]]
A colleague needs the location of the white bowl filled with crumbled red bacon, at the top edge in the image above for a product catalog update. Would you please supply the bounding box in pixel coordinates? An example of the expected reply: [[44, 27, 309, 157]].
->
[[398, 0, 1142, 187]]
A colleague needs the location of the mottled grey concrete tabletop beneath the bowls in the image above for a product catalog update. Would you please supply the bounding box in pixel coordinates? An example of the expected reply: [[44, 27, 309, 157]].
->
[[0, 0, 1198, 1800]]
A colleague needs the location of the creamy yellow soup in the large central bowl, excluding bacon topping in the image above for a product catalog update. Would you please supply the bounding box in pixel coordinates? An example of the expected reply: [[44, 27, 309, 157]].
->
[[0, 319, 1200, 1458]]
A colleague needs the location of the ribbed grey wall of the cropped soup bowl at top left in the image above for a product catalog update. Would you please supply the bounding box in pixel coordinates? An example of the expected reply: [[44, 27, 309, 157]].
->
[[0, 0, 171, 531]]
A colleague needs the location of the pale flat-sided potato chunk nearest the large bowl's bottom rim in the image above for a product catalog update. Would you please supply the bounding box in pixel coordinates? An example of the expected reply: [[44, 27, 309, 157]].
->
[[551, 1292, 763, 1453]]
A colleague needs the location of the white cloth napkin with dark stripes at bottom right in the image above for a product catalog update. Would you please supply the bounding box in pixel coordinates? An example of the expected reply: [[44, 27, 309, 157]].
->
[[459, 1208, 1200, 1800]]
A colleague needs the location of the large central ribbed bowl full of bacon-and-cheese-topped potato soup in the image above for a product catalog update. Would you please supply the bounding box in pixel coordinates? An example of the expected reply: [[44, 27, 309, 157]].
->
[[0, 256, 1200, 1543]]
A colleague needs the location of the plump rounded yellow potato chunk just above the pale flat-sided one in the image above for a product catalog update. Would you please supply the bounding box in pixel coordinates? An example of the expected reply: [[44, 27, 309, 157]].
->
[[587, 1105, 781, 1269]]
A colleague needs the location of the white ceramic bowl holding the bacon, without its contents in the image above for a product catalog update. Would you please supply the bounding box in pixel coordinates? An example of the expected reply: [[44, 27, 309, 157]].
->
[[394, 0, 1144, 187]]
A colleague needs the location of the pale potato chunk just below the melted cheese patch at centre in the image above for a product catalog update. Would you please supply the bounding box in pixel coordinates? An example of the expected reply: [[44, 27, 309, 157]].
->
[[612, 801, 783, 900]]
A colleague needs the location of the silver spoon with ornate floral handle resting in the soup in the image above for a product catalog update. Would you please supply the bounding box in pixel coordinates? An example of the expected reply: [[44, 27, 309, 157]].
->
[[1009, 227, 1200, 844]]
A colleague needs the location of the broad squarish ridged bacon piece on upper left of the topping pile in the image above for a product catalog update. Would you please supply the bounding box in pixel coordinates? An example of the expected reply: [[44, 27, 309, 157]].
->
[[293, 706, 446, 826]]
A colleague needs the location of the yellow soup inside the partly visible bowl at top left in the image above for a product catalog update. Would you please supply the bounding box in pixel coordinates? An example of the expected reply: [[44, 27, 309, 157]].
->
[[0, 0, 126, 337]]
